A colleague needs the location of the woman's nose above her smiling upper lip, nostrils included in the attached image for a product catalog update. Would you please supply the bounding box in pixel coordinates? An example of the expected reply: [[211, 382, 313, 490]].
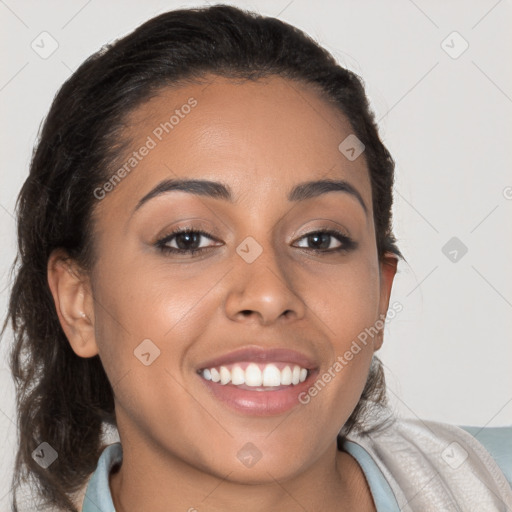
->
[[225, 243, 306, 325]]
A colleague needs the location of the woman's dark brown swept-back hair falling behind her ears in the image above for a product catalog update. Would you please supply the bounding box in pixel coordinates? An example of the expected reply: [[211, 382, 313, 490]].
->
[[4, 5, 401, 511]]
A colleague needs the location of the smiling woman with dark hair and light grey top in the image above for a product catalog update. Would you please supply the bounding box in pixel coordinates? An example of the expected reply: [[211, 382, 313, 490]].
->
[[3, 6, 512, 512]]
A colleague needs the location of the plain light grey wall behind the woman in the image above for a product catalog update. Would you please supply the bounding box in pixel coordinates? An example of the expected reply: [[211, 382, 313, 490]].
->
[[0, 0, 512, 504]]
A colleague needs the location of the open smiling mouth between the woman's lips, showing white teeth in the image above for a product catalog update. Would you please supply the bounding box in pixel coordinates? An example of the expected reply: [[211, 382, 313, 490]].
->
[[197, 361, 310, 391]]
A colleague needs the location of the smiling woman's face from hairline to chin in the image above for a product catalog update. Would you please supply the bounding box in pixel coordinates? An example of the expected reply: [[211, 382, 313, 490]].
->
[[72, 78, 396, 482]]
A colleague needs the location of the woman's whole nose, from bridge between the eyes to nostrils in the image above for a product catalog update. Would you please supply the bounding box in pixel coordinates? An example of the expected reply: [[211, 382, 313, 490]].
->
[[226, 236, 304, 323]]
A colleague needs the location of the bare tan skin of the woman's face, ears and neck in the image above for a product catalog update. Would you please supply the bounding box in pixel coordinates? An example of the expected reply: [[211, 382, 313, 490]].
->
[[48, 77, 397, 512]]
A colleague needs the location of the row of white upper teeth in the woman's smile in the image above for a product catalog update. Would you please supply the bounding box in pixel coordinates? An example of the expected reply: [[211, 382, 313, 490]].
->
[[201, 363, 308, 386]]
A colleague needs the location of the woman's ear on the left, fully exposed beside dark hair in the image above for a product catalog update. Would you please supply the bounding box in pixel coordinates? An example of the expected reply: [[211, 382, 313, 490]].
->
[[47, 249, 98, 357]]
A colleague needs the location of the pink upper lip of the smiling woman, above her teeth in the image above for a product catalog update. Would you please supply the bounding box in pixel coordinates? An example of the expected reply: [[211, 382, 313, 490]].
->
[[199, 345, 317, 370]]
